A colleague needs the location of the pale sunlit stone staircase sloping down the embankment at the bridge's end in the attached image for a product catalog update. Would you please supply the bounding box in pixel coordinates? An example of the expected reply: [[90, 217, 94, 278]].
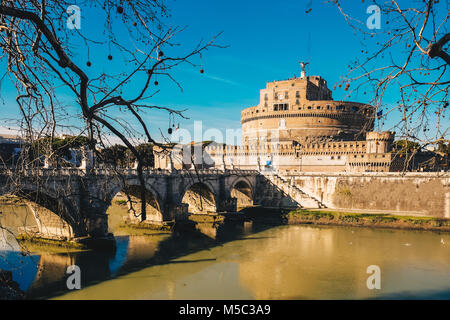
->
[[264, 173, 326, 209]]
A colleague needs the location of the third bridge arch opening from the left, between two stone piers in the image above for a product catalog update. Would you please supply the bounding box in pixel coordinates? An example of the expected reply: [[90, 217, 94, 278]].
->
[[181, 182, 217, 214]]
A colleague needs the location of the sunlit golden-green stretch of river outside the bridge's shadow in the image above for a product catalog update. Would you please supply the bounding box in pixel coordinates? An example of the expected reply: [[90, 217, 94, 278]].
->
[[53, 226, 450, 299]]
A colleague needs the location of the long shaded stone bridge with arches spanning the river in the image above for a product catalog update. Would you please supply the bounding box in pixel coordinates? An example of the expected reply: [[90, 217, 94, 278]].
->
[[0, 168, 310, 239]]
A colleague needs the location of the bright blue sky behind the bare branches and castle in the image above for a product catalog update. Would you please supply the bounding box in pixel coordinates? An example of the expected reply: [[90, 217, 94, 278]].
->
[[2, 0, 448, 139]]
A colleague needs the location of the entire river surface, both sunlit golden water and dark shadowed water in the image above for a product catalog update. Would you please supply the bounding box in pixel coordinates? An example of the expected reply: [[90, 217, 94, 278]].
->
[[0, 204, 450, 299]]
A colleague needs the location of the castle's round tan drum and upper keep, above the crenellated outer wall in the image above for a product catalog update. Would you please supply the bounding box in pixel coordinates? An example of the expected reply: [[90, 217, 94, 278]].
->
[[241, 76, 375, 145]]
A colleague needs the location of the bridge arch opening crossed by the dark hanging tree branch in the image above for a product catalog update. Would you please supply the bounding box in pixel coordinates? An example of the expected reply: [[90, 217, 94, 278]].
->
[[108, 184, 164, 222]]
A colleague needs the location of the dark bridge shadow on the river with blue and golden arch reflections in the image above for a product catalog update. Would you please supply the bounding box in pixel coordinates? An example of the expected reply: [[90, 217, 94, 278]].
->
[[0, 214, 276, 299]]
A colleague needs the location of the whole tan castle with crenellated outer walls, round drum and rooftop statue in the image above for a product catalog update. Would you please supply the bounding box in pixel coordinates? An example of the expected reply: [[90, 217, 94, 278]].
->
[[155, 63, 410, 172]]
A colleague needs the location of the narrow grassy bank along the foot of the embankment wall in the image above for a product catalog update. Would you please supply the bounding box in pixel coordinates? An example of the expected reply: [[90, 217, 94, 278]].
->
[[285, 210, 450, 231]]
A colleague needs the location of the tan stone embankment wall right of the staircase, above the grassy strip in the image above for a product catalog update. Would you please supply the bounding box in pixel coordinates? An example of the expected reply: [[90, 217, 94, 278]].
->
[[284, 172, 450, 218]]
